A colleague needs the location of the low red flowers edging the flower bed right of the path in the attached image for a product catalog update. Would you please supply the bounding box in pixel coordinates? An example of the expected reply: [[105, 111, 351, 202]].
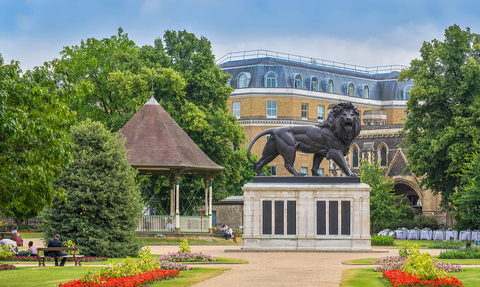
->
[[383, 270, 463, 287]]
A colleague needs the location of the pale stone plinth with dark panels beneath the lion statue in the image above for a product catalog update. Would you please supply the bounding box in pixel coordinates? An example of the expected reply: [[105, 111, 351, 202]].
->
[[242, 176, 372, 252]]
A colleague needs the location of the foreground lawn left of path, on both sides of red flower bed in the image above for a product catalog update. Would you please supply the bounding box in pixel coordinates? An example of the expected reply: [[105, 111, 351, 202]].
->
[[0, 266, 230, 287]]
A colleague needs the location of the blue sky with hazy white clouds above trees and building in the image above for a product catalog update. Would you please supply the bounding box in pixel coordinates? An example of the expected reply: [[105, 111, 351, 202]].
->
[[0, 0, 480, 70]]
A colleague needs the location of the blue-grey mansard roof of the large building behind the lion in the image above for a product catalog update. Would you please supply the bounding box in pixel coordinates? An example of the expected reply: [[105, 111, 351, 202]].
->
[[219, 57, 413, 101]]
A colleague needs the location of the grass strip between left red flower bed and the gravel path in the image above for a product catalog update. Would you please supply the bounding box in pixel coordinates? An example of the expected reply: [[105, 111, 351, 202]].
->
[[151, 268, 230, 287]]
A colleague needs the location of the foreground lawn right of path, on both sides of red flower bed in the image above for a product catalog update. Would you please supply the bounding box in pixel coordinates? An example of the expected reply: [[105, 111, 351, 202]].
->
[[340, 268, 480, 287]]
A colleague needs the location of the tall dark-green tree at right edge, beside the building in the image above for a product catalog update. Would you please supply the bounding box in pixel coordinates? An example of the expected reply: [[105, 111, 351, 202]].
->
[[398, 25, 480, 207]]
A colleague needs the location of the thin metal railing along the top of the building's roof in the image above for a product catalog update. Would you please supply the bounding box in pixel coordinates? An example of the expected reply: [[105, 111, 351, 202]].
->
[[215, 49, 407, 74]]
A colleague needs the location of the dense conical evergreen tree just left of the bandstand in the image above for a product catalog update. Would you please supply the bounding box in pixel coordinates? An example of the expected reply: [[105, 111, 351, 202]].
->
[[41, 119, 142, 257]]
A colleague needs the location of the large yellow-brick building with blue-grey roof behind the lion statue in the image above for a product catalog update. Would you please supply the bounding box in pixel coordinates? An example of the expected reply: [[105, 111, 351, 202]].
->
[[217, 50, 448, 224]]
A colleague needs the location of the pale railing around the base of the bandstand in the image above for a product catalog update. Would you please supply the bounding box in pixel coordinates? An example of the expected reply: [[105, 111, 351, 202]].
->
[[136, 215, 209, 232]]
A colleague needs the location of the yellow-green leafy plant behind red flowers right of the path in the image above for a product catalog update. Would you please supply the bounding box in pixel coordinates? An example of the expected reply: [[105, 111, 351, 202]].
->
[[399, 243, 447, 280]]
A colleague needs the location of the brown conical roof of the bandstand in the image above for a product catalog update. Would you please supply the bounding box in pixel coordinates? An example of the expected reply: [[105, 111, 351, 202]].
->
[[119, 97, 224, 176]]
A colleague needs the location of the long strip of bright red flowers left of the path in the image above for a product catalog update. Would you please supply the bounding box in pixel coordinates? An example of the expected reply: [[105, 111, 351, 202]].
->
[[59, 270, 180, 287]]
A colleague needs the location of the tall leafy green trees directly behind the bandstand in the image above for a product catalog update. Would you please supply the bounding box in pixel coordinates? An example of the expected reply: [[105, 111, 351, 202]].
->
[[61, 28, 246, 213]]
